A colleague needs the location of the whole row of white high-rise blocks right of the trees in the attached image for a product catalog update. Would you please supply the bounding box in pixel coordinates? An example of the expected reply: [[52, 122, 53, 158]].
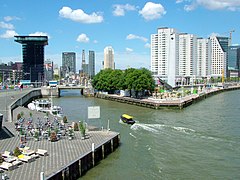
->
[[151, 27, 229, 87]]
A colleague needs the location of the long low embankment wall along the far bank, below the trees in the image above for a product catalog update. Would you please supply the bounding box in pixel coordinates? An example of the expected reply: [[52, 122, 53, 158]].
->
[[95, 86, 240, 109]]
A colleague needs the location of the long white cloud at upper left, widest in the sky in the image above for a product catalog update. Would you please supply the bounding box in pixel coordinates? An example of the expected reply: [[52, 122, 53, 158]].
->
[[59, 7, 103, 24]]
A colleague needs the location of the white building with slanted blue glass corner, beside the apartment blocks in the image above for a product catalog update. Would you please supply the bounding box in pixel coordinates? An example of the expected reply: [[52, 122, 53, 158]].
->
[[210, 36, 229, 77]]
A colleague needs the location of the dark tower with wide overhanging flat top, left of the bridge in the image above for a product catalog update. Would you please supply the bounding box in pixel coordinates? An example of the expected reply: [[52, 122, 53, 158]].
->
[[15, 36, 48, 82]]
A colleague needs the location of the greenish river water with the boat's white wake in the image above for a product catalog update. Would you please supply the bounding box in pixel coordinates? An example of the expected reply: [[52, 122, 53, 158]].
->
[[54, 90, 240, 179]]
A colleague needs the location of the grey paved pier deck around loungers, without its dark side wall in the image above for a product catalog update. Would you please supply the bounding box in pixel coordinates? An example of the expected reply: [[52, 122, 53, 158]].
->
[[0, 123, 119, 180]]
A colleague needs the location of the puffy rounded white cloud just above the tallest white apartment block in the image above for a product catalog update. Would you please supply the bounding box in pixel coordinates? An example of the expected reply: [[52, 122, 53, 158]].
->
[[139, 2, 166, 21]]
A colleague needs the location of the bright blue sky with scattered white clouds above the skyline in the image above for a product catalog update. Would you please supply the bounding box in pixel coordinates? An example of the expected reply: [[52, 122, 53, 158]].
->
[[0, 0, 240, 72]]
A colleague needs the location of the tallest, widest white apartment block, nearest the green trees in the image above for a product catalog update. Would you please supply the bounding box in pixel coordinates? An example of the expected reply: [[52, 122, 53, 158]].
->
[[151, 27, 178, 86]]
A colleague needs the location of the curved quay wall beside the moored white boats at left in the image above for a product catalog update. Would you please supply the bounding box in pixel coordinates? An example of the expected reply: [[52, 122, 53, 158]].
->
[[7, 89, 42, 122]]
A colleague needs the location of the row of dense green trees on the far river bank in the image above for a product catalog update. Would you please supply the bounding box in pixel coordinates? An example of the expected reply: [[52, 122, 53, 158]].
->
[[92, 68, 155, 97]]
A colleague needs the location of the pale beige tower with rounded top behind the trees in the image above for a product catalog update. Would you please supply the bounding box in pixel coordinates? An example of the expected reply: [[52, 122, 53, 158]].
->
[[103, 46, 115, 69]]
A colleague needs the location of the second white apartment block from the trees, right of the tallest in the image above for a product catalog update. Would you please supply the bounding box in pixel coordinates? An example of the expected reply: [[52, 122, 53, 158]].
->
[[178, 33, 197, 77]]
